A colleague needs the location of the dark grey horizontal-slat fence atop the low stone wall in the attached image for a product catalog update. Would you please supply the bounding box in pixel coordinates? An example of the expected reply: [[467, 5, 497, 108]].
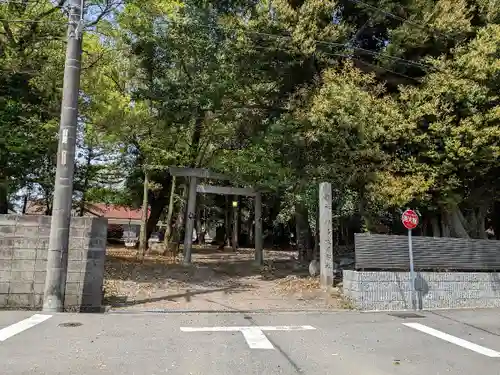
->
[[355, 233, 500, 271]]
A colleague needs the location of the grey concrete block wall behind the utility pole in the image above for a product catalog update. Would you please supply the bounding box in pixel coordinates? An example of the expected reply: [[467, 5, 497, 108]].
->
[[0, 215, 107, 311]]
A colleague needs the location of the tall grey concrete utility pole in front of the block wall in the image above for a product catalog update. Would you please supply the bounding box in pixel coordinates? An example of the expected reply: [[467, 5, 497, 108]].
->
[[43, 0, 84, 312]]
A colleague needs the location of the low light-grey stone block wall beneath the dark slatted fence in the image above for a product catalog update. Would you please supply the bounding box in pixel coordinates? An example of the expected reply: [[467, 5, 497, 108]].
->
[[343, 271, 500, 310]]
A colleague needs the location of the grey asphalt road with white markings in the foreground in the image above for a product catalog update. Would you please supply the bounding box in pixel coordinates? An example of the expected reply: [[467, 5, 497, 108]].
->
[[0, 310, 500, 375]]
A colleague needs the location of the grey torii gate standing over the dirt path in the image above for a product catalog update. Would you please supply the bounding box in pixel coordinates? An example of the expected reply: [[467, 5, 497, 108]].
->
[[169, 167, 264, 265]]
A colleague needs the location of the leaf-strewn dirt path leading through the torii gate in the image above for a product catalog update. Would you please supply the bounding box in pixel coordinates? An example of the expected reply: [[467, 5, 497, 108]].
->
[[105, 248, 345, 311]]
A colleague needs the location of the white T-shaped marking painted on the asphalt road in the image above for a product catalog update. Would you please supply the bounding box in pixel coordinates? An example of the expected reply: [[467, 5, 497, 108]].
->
[[181, 326, 316, 349]]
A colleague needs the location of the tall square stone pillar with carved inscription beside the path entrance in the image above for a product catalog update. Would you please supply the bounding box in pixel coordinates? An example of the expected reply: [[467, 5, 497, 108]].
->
[[319, 182, 333, 287]]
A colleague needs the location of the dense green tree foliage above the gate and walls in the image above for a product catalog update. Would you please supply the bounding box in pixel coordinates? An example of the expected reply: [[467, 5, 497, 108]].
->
[[0, 0, 500, 241]]
